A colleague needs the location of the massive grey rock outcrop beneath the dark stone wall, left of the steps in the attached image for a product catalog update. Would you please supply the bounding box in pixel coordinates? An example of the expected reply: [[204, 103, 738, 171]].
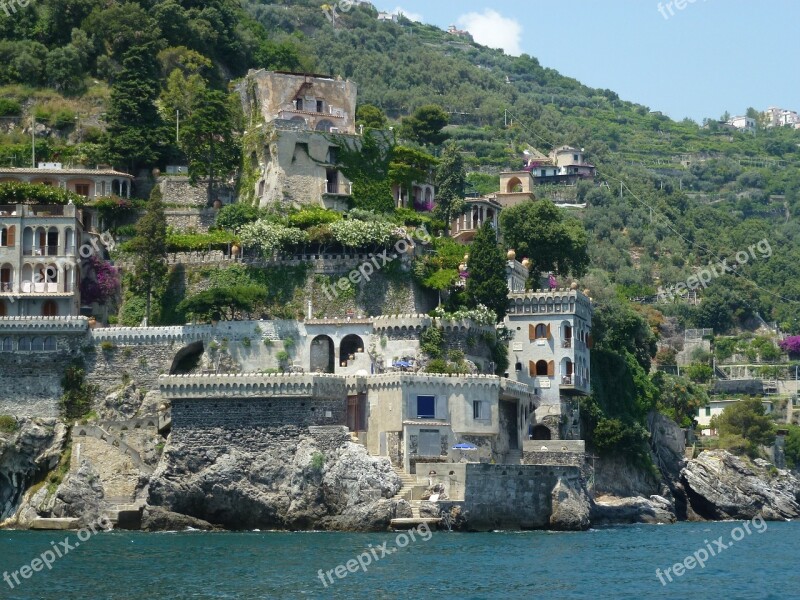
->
[[148, 426, 404, 531]]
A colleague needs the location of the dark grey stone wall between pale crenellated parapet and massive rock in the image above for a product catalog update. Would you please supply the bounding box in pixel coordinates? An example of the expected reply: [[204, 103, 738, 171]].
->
[[172, 397, 347, 431]]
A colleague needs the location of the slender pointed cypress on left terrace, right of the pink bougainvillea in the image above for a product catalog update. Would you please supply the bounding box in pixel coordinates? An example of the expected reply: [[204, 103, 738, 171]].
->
[[129, 186, 167, 324]]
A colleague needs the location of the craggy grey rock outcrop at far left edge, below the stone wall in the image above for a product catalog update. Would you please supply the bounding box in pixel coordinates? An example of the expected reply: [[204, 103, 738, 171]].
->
[[0, 418, 67, 521]]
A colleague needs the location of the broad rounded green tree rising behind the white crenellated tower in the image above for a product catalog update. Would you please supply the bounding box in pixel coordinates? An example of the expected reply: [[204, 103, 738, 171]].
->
[[500, 200, 589, 286]]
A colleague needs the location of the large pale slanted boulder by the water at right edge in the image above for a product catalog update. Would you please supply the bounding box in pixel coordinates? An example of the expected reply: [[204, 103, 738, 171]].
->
[[681, 450, 800, 520]]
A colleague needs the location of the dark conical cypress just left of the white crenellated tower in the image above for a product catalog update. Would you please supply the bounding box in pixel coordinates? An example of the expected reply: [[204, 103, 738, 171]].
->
[[466, 221, 508, 322]]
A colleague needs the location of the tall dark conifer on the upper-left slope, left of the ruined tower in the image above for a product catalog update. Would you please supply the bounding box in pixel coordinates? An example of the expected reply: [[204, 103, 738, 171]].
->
[[108, 44, 166, 171]]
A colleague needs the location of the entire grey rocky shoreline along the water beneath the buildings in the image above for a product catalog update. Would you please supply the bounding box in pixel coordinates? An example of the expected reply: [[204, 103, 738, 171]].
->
[[0, 416, 800, 531]]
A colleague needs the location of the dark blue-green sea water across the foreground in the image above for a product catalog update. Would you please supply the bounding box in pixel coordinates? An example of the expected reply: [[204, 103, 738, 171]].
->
[[0, 522, 800, 600]]
